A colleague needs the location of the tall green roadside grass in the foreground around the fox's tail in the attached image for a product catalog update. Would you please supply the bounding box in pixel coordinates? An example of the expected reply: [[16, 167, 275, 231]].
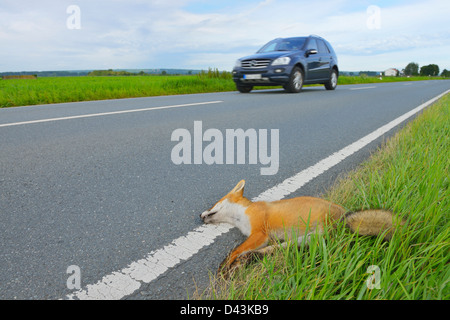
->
[[200, 95, 450, 300]]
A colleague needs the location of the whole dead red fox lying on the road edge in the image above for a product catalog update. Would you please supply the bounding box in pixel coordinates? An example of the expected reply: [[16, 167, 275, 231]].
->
[[200, 180, 404, 269]]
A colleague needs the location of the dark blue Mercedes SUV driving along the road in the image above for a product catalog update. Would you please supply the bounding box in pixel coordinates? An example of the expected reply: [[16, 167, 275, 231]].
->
[[233, 35, 339, 93]]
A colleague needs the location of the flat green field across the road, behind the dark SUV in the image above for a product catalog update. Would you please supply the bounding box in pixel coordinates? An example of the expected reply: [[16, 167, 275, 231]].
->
[[0, 70, 448, 108]]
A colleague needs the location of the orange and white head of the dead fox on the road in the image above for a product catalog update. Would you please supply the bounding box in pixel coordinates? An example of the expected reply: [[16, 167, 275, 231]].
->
[[200, 180, 250, 225]]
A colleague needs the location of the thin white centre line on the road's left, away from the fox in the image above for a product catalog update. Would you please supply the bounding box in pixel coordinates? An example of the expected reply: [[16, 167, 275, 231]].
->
[[0, 101, 223, 128]]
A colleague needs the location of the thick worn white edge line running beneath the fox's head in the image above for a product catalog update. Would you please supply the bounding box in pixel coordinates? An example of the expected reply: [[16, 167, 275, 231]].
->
[[66, 90, 450, 300]]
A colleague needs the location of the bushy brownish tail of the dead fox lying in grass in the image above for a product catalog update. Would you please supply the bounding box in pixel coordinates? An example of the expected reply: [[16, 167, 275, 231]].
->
[[344, 210, 406, 240]]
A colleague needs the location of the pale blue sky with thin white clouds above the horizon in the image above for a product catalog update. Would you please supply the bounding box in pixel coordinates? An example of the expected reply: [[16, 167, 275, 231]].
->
[[0, 0, 450, 72]]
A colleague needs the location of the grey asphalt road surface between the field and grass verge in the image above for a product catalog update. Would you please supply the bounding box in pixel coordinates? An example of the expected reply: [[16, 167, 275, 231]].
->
[[0, 81, 450, 299]]
